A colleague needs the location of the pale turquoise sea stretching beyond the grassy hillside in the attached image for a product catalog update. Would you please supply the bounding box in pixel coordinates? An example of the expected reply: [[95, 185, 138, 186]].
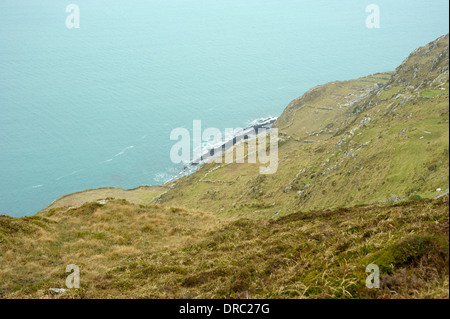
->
[[0, 0, 449, 216]]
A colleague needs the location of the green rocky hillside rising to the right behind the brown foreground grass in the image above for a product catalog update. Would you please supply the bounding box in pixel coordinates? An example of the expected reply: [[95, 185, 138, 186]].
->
[[158, 35, 449, 218]]
